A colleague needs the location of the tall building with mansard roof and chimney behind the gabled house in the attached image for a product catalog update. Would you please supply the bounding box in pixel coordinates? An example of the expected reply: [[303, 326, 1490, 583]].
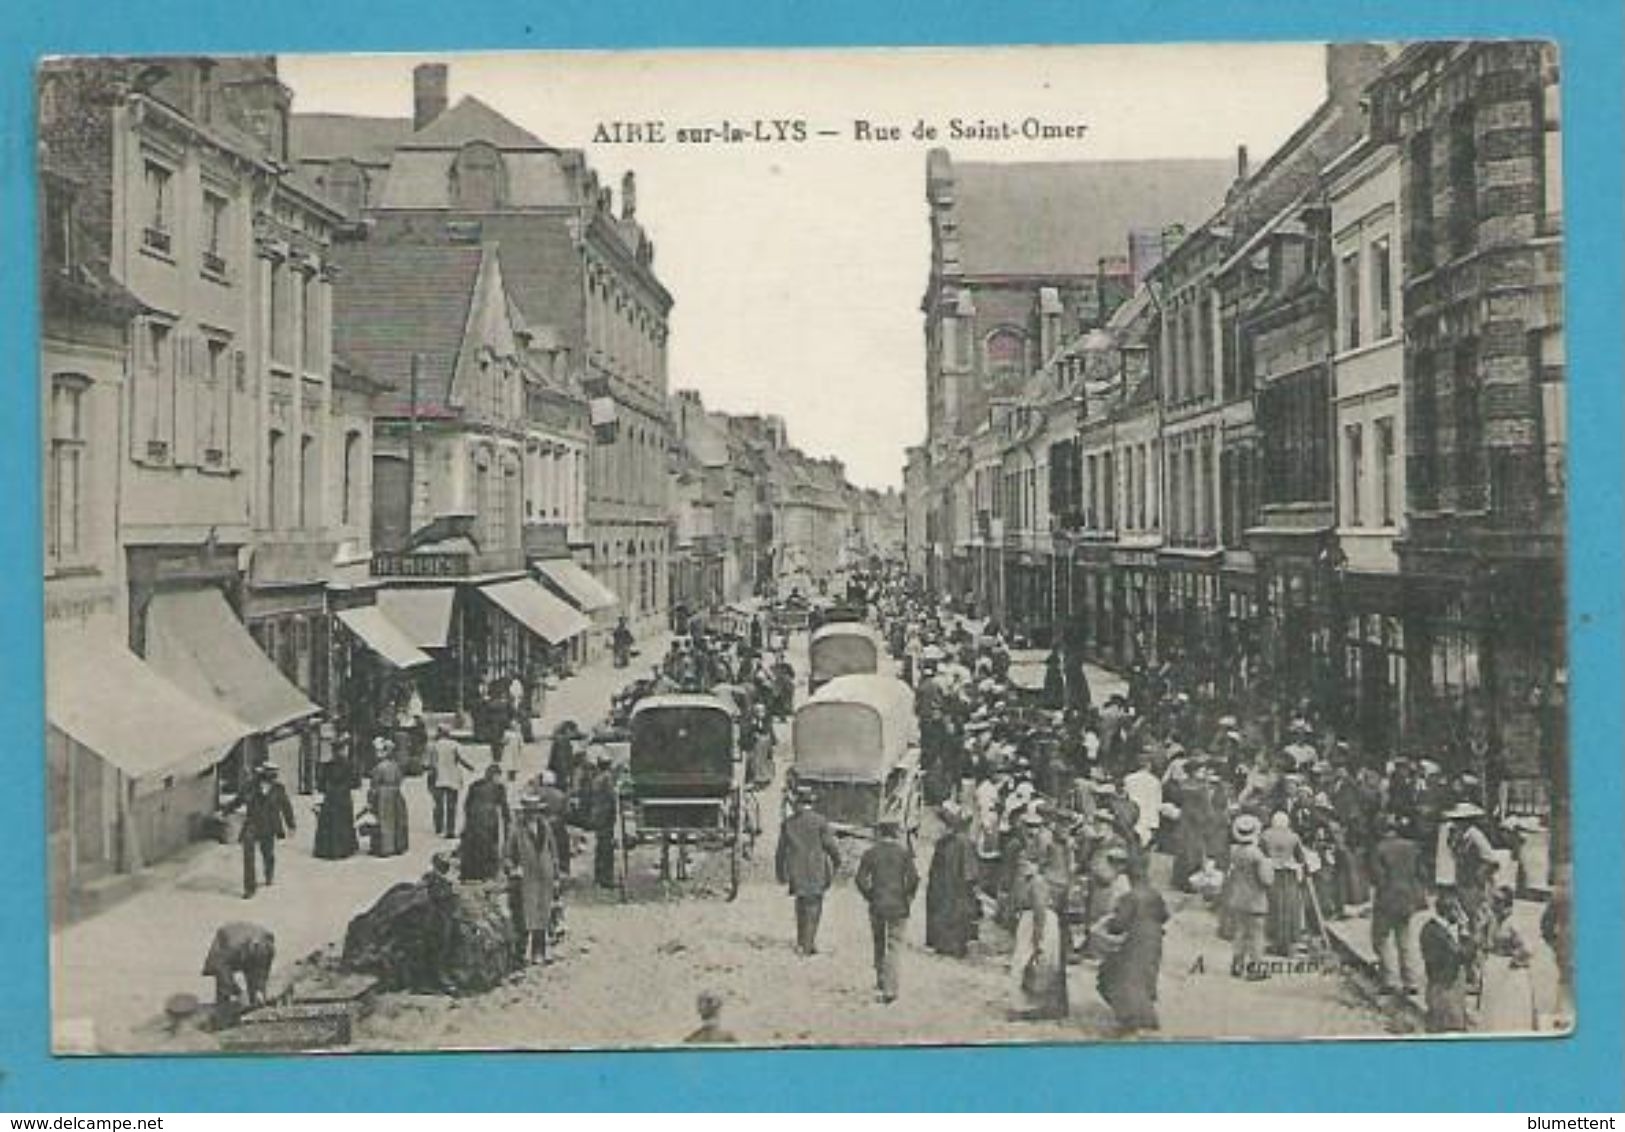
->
[[293, 63, 671, 637]]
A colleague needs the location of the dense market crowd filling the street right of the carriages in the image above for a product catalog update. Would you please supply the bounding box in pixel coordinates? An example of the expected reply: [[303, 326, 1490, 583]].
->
[[851, 568, 1563, 1031]]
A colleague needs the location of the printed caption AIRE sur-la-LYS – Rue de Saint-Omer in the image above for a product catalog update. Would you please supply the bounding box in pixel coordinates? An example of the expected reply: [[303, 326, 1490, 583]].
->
[[593, 115, 1089, 146]]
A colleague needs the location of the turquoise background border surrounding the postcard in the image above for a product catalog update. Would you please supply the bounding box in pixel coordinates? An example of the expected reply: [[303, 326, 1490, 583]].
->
[[0, 0, 1625, 1113]]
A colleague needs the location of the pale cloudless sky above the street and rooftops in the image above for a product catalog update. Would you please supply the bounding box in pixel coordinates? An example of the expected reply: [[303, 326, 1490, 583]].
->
[[280, 44, 1324, 489]]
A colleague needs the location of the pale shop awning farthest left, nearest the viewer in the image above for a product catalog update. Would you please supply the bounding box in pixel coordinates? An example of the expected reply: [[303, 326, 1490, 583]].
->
[[46, 630, 250, 793]]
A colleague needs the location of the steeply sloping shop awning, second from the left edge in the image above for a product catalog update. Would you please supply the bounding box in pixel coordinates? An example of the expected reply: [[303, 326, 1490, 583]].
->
[[146, 590, 320, 734]]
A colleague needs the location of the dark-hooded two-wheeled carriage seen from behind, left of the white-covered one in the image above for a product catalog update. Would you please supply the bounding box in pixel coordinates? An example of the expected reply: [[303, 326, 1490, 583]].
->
[[616, 693, 762, 900]]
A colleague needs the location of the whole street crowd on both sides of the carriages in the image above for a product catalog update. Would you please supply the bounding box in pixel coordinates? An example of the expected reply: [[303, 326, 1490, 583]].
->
[[203, 570, 1567, 1035]]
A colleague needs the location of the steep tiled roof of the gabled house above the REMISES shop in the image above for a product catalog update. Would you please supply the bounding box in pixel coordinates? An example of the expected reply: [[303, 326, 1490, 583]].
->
[[333, 242, 486, 413]]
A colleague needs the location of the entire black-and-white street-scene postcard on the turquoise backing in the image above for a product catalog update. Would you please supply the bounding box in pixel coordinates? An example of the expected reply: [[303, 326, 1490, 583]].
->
[[37, 41, 1575, 1054]]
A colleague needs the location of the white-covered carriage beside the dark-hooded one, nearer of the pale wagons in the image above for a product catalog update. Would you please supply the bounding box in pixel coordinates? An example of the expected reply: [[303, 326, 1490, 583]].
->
[[785, 674, 923, 848]]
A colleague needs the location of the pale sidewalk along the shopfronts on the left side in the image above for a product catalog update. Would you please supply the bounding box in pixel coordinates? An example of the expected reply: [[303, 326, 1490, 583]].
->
[[50, 637, 666, 1052]]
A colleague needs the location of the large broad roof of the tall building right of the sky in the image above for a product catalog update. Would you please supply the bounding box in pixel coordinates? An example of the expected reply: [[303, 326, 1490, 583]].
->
[[952, 159, 1235, 276]]
